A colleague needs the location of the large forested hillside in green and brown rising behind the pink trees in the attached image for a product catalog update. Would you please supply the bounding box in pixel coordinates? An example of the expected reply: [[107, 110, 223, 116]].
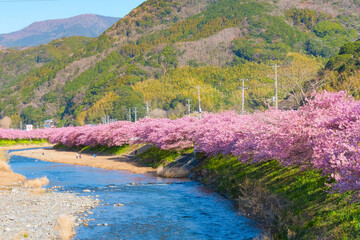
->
[[0, 0, 360, 127]]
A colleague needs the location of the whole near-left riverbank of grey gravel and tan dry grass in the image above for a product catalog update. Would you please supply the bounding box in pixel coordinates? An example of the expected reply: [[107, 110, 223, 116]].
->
[[0, 149, 99, 240]]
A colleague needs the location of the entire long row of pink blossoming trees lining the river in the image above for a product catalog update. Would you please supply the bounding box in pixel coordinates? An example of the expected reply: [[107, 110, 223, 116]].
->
[[0, 91, 360, 192]]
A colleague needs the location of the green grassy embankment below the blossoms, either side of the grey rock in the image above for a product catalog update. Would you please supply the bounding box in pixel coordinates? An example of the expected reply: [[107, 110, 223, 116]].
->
[[138, 148, 360, 239]]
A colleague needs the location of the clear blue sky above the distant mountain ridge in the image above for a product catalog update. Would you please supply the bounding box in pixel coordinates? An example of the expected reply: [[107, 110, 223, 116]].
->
[[0, 0, 144, 34]]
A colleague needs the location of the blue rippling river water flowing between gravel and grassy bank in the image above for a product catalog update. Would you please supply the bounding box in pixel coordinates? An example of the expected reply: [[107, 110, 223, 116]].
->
[[10, 149, 260, 240]]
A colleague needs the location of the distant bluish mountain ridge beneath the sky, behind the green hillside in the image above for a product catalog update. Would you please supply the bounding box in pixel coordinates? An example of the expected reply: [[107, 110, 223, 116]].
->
[[0, 14, 119, 47]]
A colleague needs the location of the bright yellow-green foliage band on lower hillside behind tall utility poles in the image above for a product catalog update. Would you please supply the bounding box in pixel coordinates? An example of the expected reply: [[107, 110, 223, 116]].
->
[[133, 53, 322, 111]]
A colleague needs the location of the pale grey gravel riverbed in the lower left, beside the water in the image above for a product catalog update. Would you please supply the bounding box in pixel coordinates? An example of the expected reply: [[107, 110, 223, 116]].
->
[[0, 186, 99, 240]]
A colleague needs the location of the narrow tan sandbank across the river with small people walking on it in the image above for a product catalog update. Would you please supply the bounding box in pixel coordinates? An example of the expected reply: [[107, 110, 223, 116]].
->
[[12, 149, 155, 173]]
